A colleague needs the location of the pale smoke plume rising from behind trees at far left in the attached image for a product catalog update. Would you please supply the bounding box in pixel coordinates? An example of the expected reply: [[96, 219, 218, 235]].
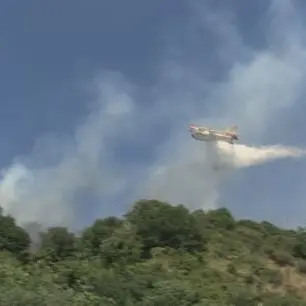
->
[[0, 74, 133, 227]]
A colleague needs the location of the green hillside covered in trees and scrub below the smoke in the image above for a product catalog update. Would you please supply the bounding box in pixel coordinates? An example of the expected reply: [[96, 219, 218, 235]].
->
[[0, 200, 306, 306]]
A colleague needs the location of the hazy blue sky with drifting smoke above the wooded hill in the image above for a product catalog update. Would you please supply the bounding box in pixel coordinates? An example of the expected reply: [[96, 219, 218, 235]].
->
[[0, 0, 306, 230]]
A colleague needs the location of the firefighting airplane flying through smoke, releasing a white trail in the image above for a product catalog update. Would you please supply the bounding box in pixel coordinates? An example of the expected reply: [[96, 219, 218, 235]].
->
[[189, 124, 239, 144]]
